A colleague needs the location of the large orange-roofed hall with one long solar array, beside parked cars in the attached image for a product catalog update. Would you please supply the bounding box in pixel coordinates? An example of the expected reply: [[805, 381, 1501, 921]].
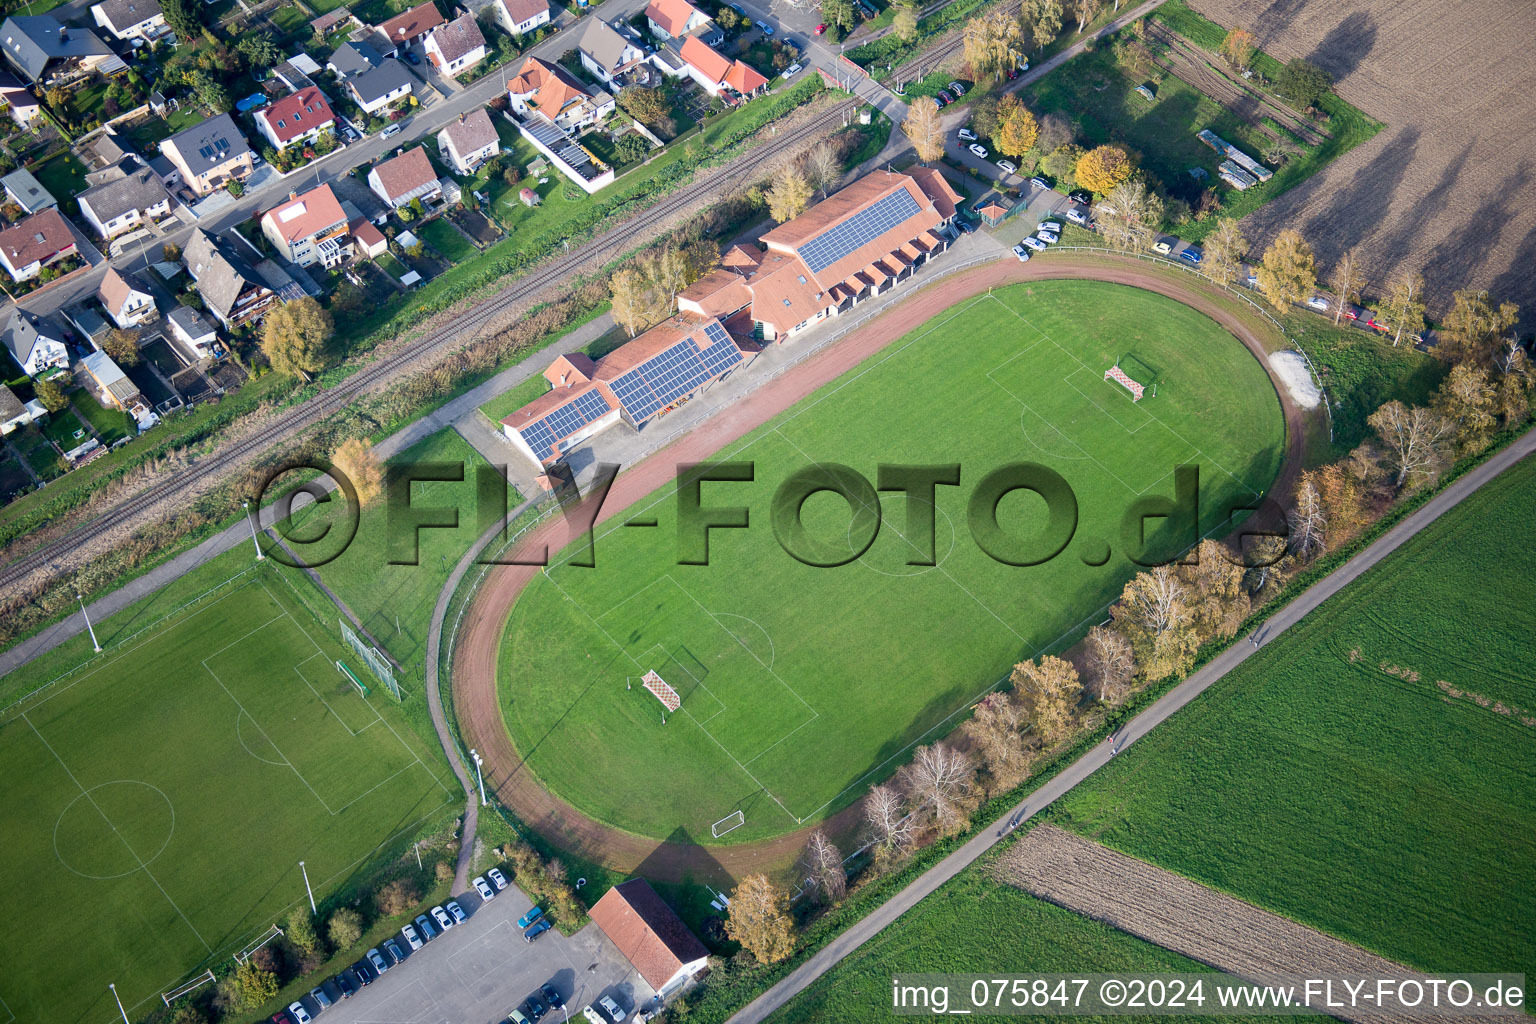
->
[[677, 167, 962, 341]]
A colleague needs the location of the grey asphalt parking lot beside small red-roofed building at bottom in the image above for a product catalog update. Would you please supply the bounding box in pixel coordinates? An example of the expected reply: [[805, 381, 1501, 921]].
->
[[304, 886, 654, 1024]]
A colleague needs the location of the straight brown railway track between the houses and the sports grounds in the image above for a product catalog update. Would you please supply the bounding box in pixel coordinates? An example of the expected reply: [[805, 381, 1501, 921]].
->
[[0, 98, 857, 588]]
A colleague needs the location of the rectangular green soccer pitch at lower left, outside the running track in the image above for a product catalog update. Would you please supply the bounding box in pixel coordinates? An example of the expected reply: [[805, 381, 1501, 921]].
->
[[0, 568, 458, 1024]]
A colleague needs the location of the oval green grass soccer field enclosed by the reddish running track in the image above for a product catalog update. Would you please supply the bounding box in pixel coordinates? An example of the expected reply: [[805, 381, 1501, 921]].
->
[[498, 281, 1284, 841]]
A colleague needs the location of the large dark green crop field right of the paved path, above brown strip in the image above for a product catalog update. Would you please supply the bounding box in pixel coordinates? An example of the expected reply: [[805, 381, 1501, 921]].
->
[[1060, 459, 1536, 973]]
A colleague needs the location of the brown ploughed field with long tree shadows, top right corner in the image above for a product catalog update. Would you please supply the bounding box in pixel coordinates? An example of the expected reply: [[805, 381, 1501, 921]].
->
[[1190, 0, 1536, 327]]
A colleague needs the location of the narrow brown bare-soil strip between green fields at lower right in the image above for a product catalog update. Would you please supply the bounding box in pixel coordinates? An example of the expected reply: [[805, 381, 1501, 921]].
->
[[991, 824, 1499, 1024]]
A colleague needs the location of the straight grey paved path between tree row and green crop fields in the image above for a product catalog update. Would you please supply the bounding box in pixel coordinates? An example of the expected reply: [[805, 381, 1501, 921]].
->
[[730, 420, 1536, 1024]]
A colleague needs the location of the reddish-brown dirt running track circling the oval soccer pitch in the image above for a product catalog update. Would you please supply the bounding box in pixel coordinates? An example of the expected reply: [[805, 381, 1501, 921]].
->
[[452, 253, 1304, 880]]
